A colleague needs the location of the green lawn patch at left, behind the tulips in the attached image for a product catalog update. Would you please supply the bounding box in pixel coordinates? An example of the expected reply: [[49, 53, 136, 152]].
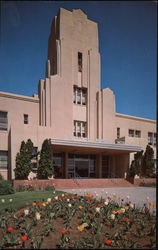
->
[[0, 191, 61, 213]]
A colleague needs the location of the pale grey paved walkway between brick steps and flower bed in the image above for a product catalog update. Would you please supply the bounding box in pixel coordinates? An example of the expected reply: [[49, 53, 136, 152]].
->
[[57, 187, 156, 208]]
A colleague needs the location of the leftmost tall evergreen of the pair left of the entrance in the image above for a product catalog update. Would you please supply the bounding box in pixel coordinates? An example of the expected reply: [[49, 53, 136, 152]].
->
[[14, 139, 33, 180]]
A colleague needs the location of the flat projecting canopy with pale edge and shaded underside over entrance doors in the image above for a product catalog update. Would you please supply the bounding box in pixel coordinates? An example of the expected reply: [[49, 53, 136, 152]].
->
[[51, 139, 142, 153]]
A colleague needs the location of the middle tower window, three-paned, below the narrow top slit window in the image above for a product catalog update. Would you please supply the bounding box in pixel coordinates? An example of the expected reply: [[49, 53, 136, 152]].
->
[[73, 86, 87, 105]]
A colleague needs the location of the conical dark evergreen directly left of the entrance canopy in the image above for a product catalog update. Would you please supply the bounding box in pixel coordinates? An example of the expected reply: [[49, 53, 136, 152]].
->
[[37, 139, 54, 179]]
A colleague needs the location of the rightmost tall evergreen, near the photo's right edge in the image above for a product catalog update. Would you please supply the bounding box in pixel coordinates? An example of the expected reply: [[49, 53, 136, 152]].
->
[[142, 145, 154, 177]]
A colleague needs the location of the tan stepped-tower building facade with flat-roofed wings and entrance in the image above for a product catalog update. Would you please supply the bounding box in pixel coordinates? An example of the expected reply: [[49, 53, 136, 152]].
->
[[0, 8, 156, 179]]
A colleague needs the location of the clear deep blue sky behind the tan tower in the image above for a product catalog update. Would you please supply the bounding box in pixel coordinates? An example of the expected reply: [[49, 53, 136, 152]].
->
[[0, 1, 157, 119]]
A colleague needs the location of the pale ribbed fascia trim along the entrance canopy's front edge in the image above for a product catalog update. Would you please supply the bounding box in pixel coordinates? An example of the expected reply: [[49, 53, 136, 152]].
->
[[51, 139, 142, 152]]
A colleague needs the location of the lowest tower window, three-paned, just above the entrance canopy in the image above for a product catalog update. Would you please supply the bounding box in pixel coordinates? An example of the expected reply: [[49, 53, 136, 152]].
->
[[74, 121, 87, 138]]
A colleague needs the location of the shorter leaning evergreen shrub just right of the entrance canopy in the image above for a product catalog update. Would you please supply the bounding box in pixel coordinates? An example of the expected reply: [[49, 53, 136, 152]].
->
[[128, 151, 143, 178]]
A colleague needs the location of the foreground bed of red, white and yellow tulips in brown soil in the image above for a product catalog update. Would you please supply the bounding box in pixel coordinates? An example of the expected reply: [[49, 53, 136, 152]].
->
[[0, 191, 156, 249]]
